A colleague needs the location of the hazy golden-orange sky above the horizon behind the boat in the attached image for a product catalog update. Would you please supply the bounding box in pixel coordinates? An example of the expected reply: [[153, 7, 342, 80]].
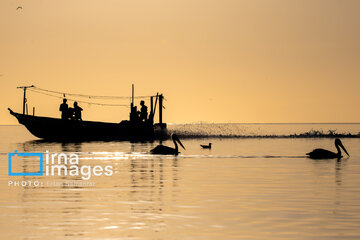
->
[[0, 0, 360, 124]]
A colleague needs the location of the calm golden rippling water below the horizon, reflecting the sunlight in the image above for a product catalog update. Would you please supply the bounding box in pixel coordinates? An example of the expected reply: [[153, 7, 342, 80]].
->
[[0, 126, 360, 240]]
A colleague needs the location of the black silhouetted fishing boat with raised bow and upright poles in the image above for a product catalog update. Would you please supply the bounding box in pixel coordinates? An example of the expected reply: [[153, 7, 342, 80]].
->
[[8, 86, 169, 141]]
